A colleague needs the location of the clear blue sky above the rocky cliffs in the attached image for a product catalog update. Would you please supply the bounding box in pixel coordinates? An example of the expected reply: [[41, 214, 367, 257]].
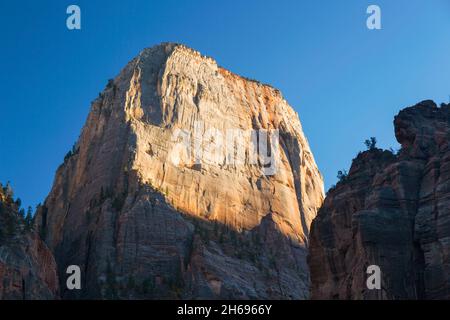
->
[[0, 0, 450, 206]]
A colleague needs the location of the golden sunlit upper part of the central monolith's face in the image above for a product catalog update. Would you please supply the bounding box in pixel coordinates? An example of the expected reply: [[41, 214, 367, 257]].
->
[[129, 46, 323, 242]]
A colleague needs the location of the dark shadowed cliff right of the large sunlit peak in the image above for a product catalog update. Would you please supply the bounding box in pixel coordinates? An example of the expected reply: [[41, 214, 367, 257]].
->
[[308, 101, 450, 299]]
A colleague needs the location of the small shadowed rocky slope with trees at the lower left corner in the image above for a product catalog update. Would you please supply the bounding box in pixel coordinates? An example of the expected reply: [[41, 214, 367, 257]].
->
[[0, 185, 58, 300]]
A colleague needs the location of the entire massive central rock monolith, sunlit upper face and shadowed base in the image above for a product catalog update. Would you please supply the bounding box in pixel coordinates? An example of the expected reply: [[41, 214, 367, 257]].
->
[[37, 44, 323, 299]]
